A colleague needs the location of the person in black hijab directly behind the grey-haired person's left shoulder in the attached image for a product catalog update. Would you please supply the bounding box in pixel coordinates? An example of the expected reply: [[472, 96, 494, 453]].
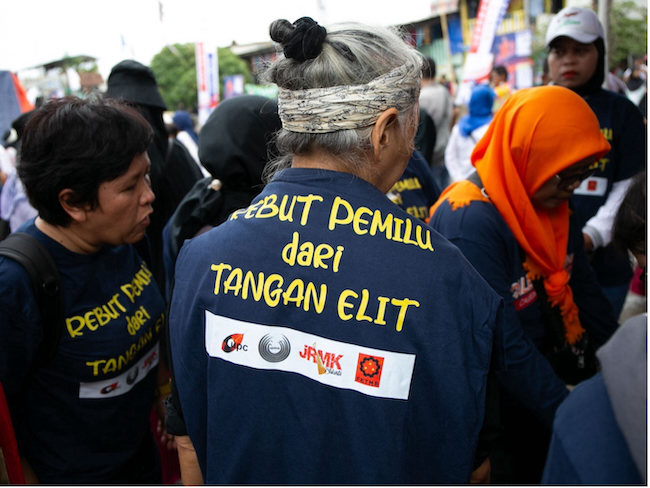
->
[[163, 95, 280, 293]]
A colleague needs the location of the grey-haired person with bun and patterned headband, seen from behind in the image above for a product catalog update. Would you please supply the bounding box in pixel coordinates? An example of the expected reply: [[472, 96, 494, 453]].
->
[[169, 18, 502, 484]]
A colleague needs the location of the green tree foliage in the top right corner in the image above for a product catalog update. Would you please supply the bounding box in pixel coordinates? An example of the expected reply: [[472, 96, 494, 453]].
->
[[609, 0, 648, 66]]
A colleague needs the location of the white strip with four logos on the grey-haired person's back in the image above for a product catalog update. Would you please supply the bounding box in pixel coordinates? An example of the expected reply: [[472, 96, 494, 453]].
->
[[205, 310, 415, 400]]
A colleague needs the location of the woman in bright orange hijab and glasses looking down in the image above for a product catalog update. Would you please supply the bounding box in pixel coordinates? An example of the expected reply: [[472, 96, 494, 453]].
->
[[429, 86, 617, 484]]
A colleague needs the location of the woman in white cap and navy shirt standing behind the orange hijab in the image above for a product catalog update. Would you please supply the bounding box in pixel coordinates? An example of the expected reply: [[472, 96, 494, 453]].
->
[[546, 7, 647, 316]]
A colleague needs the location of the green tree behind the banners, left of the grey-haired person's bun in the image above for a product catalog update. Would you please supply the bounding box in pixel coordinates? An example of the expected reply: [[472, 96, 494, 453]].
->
[[151, 43, 253, 110]]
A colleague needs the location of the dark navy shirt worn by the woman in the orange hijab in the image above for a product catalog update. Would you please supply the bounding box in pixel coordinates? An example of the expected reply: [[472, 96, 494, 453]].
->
[[429, 201, 617, 427]]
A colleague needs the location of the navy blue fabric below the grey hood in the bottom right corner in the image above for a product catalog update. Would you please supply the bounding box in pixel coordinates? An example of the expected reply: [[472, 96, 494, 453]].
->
[[542, 373, 645, 485]]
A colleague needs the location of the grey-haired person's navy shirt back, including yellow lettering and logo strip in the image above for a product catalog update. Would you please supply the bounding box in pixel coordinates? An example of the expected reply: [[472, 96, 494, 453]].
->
[[170, 169, 500, 484]]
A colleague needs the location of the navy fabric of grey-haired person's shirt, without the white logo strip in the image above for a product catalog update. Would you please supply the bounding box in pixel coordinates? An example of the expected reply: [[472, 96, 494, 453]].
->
[[169, 168, 502, 484]]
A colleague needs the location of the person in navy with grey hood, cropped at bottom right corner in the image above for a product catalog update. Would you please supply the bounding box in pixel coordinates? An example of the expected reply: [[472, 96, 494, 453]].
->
[[542, 313, 648, 485]]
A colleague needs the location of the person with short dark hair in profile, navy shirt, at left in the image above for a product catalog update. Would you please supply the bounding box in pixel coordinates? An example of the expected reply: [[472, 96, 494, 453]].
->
[[0, 97, 167, 484]]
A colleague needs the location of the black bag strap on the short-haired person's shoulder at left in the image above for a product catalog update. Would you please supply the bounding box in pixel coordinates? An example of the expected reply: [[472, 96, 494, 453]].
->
[[0, 232, 63, 367]]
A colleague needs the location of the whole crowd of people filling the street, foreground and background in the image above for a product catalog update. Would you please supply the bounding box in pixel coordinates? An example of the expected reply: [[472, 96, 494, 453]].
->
[[0, 7, 647, 485]]
